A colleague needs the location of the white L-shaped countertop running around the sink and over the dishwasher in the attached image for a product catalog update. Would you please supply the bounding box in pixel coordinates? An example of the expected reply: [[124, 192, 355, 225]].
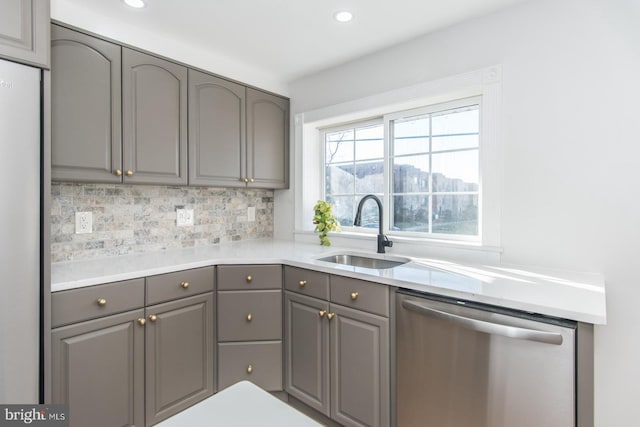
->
[[51, 239, 606, 324]]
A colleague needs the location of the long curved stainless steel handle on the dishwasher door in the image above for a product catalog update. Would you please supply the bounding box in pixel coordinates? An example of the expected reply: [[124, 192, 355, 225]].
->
[[402, 300, 562, 345]]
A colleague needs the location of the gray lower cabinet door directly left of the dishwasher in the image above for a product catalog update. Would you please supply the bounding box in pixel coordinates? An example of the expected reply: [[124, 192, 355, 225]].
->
[[330, 304, 390, 427]]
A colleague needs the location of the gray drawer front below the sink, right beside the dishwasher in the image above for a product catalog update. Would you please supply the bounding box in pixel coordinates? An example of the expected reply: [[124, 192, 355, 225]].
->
[[331, 275, 389, 317]]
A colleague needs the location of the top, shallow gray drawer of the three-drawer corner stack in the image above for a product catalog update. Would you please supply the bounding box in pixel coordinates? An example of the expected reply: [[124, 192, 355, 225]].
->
[[218, 265, 282, 291]]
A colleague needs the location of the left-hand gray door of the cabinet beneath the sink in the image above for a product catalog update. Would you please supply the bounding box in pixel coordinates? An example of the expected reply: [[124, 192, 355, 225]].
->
[[285, 292, 329, 415]]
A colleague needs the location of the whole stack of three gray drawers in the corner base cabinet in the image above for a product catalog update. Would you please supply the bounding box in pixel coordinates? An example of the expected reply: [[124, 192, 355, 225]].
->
[[217, 265, 283, 391]]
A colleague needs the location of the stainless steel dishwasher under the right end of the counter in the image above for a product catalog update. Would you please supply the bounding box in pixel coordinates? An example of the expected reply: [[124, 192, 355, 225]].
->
[[396, 290, 576, 427]]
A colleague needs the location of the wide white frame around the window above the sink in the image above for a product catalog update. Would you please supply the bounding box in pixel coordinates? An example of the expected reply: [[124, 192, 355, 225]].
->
[[293, 65, 503, 254]]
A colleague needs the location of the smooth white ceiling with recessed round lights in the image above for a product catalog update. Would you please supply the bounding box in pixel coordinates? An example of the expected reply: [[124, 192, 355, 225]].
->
[[51, 0, 526, 94]]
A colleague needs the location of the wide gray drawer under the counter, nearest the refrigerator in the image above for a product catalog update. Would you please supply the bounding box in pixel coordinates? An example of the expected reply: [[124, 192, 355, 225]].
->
[[51, 279, 144, 328]]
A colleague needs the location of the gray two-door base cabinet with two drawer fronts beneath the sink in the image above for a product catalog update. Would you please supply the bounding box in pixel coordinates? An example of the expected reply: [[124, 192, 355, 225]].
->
[[285, 267, 390, 427]]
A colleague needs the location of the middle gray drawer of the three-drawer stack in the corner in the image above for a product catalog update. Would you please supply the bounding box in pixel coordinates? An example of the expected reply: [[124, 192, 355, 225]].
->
[[218, 291, 282, 341]]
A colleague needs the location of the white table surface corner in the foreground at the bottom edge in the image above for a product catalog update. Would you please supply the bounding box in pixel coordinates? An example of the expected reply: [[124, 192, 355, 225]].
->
[[156, 381, 322, 427]]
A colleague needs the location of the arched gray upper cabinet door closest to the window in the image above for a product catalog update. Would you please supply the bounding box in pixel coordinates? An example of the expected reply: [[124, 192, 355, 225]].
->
[[247, 88, 289, 188]]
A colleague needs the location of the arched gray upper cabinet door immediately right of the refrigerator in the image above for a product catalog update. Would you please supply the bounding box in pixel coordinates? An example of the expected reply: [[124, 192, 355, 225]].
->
[[51, 25, 122, 182]]
